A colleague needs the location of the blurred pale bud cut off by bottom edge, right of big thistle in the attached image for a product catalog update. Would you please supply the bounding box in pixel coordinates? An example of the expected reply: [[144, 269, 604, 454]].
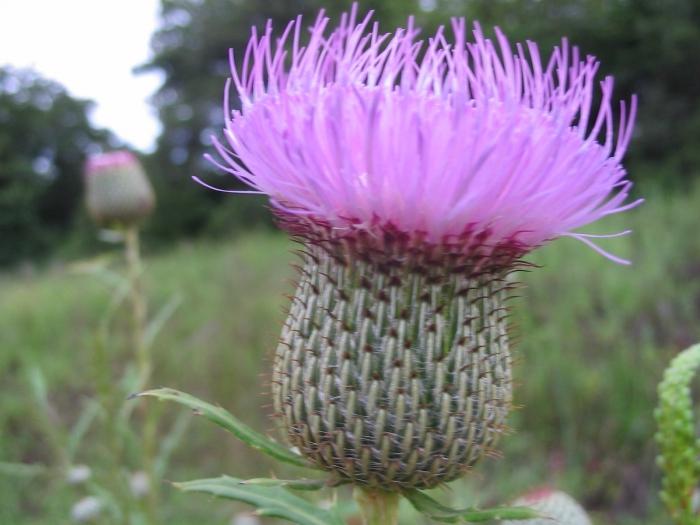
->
[[502, 488, 591, 525]]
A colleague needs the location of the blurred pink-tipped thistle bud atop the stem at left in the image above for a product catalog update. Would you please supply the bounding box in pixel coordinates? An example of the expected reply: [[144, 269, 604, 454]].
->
[[85, 151, 155, 226]]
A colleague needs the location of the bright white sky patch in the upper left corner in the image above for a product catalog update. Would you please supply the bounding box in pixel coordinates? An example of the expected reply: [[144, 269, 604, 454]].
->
[[0, 0, 161, 151]]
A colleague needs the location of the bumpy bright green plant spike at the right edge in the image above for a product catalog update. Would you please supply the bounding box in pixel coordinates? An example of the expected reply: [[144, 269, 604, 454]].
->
[[655, 345, 700, 525]]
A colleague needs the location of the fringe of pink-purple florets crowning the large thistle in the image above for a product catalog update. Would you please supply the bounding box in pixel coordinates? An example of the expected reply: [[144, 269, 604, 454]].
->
[[204, 5, 640, 262]]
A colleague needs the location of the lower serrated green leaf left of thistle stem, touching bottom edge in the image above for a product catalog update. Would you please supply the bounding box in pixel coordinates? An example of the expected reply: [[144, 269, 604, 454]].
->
[[175, 476, 344, 525]]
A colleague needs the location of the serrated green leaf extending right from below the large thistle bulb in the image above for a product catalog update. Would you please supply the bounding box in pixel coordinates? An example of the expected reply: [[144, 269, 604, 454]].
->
[[403, 490, 540, 523]]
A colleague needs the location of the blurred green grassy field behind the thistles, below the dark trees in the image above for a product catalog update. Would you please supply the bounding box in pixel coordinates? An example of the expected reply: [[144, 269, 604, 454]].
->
[[0, 182, 700, 525]]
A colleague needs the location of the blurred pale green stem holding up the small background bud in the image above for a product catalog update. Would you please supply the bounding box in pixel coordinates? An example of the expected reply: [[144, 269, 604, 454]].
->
[[124, 226, 160, 525]]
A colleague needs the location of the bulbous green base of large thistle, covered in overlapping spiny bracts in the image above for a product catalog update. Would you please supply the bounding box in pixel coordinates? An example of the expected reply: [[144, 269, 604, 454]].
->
[[273, 231, 511, 490]]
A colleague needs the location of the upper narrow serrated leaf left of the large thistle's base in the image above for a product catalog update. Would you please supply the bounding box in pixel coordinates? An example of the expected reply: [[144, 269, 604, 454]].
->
[[138, 388, 314, 468]]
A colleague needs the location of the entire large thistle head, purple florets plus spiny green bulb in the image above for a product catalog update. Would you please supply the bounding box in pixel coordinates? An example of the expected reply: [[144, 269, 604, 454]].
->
[[205, 5, 636, 490]]
